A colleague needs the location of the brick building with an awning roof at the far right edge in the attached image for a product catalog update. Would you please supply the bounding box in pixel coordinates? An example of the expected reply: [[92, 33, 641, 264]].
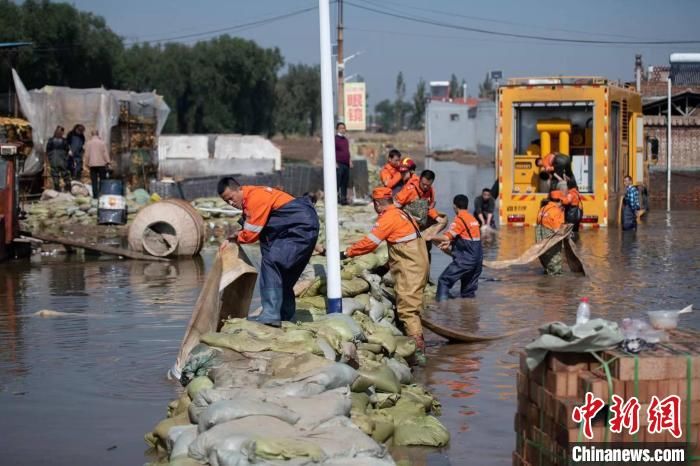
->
[[637, 59, 700, 209]]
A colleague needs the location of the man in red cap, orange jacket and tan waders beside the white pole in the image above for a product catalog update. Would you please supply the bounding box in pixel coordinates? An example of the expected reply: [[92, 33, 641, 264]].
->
[[341, 187, 430, 365]]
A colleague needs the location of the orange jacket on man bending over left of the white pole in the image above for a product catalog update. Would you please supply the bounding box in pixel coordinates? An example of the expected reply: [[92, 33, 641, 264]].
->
[[238, 186, 294, 244]]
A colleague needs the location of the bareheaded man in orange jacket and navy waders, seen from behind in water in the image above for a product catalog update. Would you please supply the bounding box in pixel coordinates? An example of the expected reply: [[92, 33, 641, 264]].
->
[[433, 194, 484, 301]]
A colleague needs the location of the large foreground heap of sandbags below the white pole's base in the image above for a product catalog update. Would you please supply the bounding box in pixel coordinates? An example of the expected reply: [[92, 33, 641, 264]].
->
[[145, 310, 449, 466]]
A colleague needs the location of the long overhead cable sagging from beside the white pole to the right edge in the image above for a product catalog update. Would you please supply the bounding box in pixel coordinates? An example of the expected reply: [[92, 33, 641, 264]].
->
[[347, 1, 700, 45]]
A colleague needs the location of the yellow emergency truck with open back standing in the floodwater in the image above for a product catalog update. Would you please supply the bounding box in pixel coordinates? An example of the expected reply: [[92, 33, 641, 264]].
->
[[496, 76, 648, 227]]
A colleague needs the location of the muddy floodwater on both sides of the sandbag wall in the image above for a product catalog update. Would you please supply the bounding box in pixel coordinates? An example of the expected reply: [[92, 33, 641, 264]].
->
[[0, 164, 700, 466]]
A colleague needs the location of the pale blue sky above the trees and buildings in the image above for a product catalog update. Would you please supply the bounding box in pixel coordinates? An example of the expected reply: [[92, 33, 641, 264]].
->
[[72, 0, 700, 107]]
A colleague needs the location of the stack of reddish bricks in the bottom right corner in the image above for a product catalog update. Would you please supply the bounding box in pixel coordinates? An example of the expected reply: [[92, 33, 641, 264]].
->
[[513, 330, 700, 466]]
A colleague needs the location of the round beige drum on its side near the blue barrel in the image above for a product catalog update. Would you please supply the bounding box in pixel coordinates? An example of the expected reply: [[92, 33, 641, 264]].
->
[[129, 199, 206, 257]]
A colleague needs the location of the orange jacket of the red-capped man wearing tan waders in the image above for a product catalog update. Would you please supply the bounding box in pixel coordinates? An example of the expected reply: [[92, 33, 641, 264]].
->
[[345, 205, 418, 257]]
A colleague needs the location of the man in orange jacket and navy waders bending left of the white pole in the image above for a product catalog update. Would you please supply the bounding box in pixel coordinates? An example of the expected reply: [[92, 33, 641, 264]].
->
[[218, 177, 319, 326]]
